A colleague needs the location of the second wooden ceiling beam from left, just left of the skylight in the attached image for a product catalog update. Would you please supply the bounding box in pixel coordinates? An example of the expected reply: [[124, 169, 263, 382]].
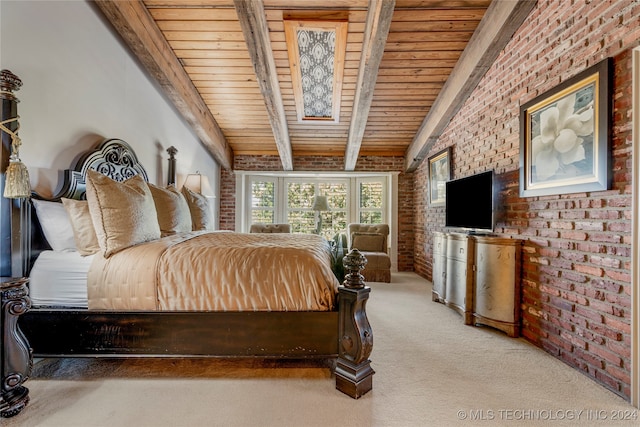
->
[[233, 0, 293, 171]]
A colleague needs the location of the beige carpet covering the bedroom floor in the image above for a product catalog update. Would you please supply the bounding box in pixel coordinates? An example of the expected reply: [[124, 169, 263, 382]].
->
[[0, 273, 638, 427]]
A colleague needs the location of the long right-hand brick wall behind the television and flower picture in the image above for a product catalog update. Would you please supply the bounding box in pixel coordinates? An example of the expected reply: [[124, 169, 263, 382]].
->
[[414, 0, 640, 398]]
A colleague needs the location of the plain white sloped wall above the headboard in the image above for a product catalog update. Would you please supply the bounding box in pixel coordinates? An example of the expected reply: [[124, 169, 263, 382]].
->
[[0, 0, 220, 202]]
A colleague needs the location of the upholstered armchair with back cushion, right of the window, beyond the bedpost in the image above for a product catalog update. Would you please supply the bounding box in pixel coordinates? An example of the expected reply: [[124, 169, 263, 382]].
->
[[348, 223, 391, 283]]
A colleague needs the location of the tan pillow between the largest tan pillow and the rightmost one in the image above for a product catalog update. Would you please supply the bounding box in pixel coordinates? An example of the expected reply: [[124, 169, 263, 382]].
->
[[147, 183, 192, 236]]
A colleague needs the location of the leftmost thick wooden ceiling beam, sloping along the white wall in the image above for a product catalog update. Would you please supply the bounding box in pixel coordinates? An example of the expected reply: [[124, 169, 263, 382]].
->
[[95, 0, 233, 169]]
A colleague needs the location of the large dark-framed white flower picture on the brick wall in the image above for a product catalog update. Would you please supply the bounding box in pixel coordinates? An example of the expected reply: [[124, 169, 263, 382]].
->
[[520, 58, 612, 197]]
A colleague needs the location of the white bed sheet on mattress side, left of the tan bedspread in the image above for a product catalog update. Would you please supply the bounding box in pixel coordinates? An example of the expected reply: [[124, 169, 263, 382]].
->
[[29, 251, 93, 308]]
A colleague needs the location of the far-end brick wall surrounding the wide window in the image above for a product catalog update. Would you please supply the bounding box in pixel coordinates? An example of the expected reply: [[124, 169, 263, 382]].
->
[[220, 156, 414, 271]]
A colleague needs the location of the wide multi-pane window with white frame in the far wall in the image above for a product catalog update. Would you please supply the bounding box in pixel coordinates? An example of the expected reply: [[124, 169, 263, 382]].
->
[[236, 171, 397, 239]]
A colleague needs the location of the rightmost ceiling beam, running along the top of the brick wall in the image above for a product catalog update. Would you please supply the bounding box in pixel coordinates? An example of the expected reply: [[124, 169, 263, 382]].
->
[[405, 0, 537, 172]]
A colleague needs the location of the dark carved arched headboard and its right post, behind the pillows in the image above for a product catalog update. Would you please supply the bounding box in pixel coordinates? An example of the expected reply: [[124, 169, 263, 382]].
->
[[23, 139, 172, 275]]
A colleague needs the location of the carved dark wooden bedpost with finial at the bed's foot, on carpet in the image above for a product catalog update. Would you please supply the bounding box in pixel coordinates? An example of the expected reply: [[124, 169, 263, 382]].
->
[[336, 249, 375, 399]]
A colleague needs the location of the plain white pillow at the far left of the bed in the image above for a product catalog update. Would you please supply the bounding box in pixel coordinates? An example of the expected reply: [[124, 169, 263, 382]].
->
[[31, 199, 76, 251]]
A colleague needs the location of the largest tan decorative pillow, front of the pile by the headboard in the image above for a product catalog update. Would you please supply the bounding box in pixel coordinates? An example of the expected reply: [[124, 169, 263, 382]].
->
[[87, 170, 160, 258]]
